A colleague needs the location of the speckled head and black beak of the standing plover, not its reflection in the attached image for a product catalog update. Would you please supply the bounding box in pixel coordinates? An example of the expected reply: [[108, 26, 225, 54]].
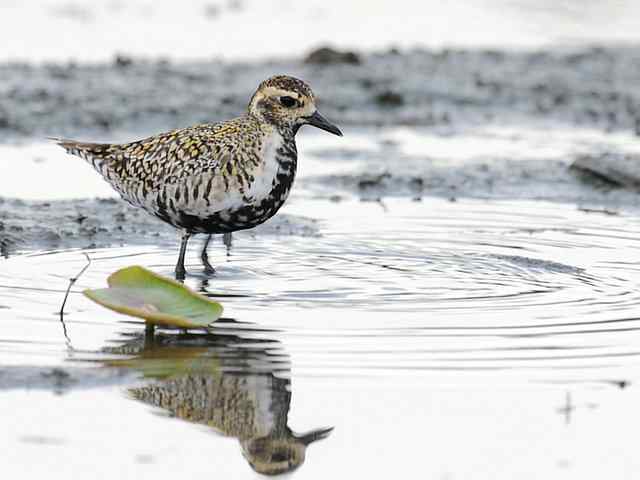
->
[[249, 75, 342, 136]]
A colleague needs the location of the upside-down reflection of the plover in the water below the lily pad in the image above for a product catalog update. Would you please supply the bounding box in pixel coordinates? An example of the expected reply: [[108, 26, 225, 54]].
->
[[102, 326, 332, 475]]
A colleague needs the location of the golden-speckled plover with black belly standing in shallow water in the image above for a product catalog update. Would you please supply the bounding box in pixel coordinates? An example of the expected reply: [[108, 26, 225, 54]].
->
[[52, 75, 342, 280]]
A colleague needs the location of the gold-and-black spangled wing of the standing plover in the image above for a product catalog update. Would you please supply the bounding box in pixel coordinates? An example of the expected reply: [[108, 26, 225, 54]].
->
[[52, 117, 262, 215]]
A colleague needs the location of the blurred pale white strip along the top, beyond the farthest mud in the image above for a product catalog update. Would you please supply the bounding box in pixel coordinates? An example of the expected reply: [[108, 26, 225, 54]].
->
[[0, 0, 640, 62]]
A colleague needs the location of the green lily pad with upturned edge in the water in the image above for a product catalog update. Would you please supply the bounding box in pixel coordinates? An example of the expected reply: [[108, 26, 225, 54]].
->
[[82, 266, 222, 328]]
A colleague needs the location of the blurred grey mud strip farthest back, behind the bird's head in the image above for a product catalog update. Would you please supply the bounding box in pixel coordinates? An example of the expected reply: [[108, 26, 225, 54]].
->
[[0, 47, 640, 142]]
